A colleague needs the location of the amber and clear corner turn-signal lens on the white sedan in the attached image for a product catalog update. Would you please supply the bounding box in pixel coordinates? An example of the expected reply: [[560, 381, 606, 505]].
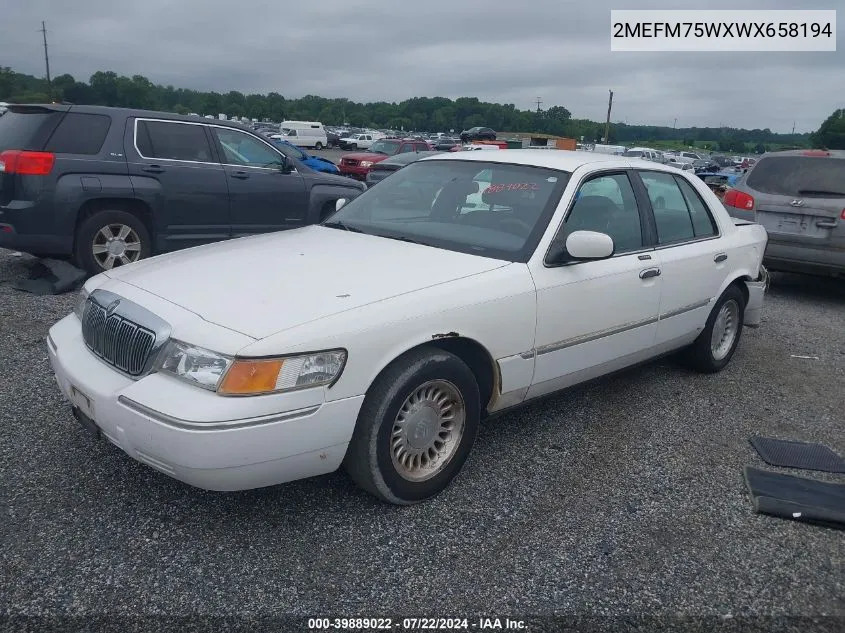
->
[[217, 349, 346, 396]]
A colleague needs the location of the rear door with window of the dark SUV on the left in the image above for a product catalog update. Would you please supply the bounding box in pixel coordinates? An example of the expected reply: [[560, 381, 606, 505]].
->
[[124, 118, 230, 252]]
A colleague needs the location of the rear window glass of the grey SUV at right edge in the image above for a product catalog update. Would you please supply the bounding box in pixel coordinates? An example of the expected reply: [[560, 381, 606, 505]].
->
[[746, 156, 845, 197]]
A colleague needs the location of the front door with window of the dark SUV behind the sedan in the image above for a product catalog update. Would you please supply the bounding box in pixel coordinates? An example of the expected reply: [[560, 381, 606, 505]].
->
[[210, 126, 308, 237]]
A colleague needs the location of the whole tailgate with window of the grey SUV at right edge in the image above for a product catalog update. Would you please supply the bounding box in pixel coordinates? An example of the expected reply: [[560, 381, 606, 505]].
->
[[743, 152, 845, 250]]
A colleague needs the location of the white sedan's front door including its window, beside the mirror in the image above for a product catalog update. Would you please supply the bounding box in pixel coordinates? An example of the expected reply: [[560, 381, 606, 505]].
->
[[528, 171, 662, 398]]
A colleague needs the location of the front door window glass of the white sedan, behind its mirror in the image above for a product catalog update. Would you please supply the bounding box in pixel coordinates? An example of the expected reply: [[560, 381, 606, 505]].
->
[[565, 174, 643, 253]]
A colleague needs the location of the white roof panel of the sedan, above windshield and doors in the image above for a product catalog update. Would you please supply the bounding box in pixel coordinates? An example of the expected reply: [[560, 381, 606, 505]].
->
[[416, 149, 679, 172]]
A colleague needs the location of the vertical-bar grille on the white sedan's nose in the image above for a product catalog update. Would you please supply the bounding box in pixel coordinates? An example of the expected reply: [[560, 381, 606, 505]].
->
[[82, 298, 156, 376]]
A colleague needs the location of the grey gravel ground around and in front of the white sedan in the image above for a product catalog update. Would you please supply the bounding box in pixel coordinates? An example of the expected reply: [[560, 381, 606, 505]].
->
[[0, 250, 845, 631]]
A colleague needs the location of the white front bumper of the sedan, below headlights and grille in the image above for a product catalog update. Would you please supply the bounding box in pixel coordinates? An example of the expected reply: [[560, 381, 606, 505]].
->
[[47, 315, 364, 490]]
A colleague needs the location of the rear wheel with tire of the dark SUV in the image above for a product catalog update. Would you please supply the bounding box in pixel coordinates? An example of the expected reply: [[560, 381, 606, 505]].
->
[[74, 209, 152, 275]]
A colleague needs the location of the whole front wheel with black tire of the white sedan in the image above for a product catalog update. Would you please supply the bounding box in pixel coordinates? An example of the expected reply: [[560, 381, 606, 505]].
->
[[343, 349, 481, 505]]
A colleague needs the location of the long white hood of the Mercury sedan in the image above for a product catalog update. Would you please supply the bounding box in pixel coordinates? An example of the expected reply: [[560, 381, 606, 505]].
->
[[99, 225, 508, 339]]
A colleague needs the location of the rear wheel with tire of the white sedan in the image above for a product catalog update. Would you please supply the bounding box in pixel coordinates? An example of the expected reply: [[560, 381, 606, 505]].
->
[[683, 285, 745, 374]]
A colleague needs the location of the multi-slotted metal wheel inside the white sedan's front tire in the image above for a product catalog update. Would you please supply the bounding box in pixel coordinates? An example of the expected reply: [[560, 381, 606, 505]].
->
[[390, 380, 466, 481]]
